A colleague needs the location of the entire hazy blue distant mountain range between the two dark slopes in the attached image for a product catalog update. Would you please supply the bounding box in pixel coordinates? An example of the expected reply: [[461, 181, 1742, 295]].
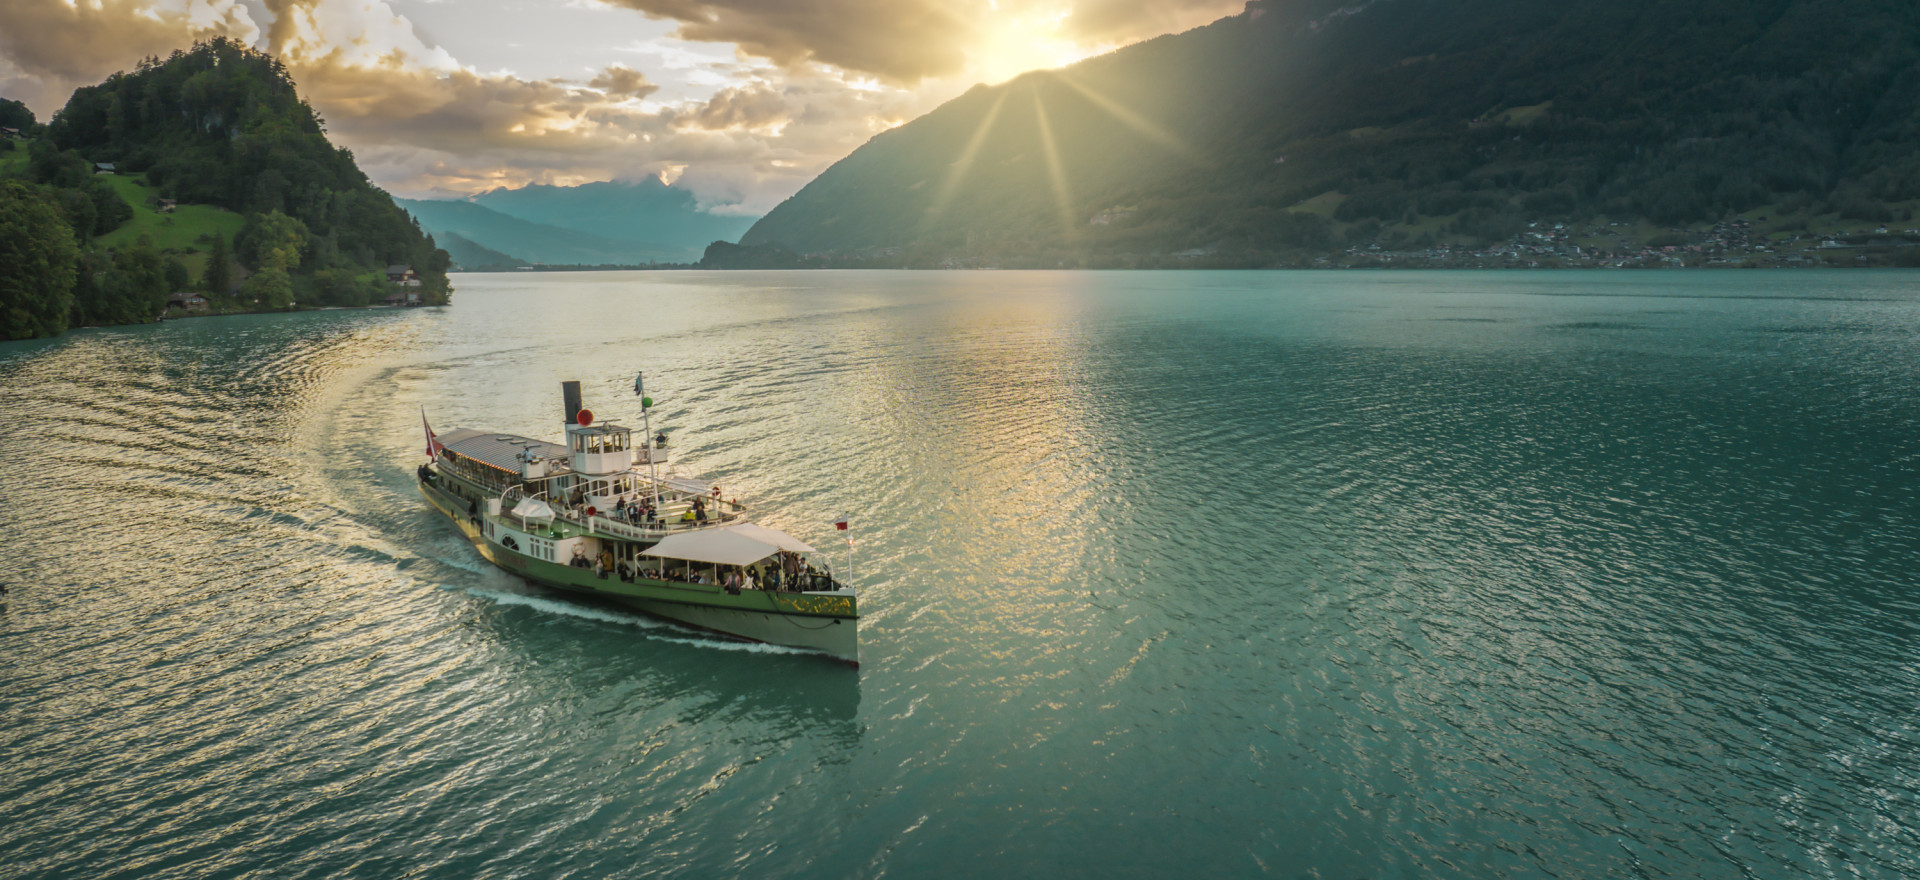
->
[[397, 177, 755, 269]]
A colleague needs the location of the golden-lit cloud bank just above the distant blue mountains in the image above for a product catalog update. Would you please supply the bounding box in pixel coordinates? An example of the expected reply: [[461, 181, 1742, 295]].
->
[[290, 48, 931, 213]]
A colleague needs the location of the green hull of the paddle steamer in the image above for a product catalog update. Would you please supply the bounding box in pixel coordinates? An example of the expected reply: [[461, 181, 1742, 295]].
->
[[430, 477, 860, 665]]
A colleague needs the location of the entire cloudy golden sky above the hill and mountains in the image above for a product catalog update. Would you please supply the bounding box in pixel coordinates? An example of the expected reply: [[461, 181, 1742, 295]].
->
[[0, 0, 1242, 213]]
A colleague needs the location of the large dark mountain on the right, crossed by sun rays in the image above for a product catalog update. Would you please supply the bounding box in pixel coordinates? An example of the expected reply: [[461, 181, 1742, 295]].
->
[[741, 0, 1920, 265]]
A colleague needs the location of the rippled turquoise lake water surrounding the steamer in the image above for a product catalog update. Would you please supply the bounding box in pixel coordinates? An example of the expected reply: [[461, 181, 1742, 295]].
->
[[0, 273, 1920, 878]]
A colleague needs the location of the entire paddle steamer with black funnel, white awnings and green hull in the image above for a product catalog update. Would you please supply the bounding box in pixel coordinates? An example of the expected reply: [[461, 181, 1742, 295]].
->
[[419, 379, 860, 665]]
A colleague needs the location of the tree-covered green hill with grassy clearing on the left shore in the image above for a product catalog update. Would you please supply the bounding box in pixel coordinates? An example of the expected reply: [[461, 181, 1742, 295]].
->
[[0, 38, 451, 338]]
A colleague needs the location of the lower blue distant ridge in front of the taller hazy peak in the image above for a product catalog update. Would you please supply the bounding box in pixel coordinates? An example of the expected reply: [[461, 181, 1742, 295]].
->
[[396, 198, 684, 265]]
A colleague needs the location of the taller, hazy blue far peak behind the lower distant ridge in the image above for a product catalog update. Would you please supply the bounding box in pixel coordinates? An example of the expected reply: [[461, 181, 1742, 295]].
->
[[470, 177, 756, 259]]
